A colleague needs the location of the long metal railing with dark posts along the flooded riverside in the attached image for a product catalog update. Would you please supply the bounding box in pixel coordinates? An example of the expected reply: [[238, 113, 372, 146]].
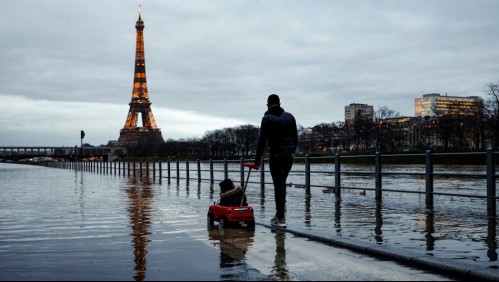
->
[[38, 149, 499, 217]]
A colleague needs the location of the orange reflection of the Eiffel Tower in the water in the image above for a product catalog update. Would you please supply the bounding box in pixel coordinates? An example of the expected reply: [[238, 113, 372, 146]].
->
[[126, 177, 154, 281]]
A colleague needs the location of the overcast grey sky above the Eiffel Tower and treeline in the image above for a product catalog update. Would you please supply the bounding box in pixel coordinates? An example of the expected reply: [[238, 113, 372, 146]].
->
[[0, 0, 499, 146]]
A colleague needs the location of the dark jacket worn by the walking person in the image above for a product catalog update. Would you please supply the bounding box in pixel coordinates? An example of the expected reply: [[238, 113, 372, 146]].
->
[[255, 106, 298, 165]]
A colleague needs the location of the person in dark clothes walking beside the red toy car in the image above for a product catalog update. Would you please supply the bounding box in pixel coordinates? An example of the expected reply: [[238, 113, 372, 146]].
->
[[255, 94, 298, 227]]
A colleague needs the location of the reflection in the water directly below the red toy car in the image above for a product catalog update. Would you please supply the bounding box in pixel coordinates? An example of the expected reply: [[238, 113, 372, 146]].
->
[[208, 228, 255, 281]]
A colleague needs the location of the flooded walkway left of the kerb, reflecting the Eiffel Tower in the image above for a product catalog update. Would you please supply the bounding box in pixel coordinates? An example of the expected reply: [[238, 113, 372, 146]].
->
[[0, 164, 497, 281]]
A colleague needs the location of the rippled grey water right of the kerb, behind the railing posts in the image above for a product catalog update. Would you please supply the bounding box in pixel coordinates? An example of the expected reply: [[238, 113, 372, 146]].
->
[[172, 163, 499, 269]]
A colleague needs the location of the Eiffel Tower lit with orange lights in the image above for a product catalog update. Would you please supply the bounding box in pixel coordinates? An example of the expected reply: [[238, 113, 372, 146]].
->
[[118, 6, 165, 156]]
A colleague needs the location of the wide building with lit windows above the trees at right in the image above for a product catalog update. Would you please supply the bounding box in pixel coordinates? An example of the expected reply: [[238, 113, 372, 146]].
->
[[414, 93, 483, 117]]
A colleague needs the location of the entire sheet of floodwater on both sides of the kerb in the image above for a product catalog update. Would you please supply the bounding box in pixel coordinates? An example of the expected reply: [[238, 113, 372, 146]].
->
[[0, 163, 498, 281]]
